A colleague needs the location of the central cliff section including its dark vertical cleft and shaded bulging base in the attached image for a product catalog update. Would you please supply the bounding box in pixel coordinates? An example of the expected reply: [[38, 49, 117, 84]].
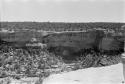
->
[[43, 30, 104, 55]]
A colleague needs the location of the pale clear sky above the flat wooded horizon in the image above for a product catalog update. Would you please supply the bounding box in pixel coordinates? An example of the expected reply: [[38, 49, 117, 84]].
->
[[0, 0, 125, 22]]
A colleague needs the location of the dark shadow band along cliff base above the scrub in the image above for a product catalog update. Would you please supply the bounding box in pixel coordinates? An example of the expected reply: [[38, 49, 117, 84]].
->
[[48, 46, 124, 63]]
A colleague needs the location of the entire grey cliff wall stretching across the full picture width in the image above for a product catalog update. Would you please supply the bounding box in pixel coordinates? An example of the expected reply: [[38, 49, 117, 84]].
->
[[0, 30, 124, 55]]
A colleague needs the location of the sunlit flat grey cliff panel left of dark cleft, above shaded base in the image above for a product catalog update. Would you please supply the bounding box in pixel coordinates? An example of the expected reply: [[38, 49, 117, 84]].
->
[[44, 32, 97, 49]]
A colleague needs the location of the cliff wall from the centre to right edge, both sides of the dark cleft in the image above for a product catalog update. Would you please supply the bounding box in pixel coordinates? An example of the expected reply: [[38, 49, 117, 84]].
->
[[43, 30, 124, 55]]
